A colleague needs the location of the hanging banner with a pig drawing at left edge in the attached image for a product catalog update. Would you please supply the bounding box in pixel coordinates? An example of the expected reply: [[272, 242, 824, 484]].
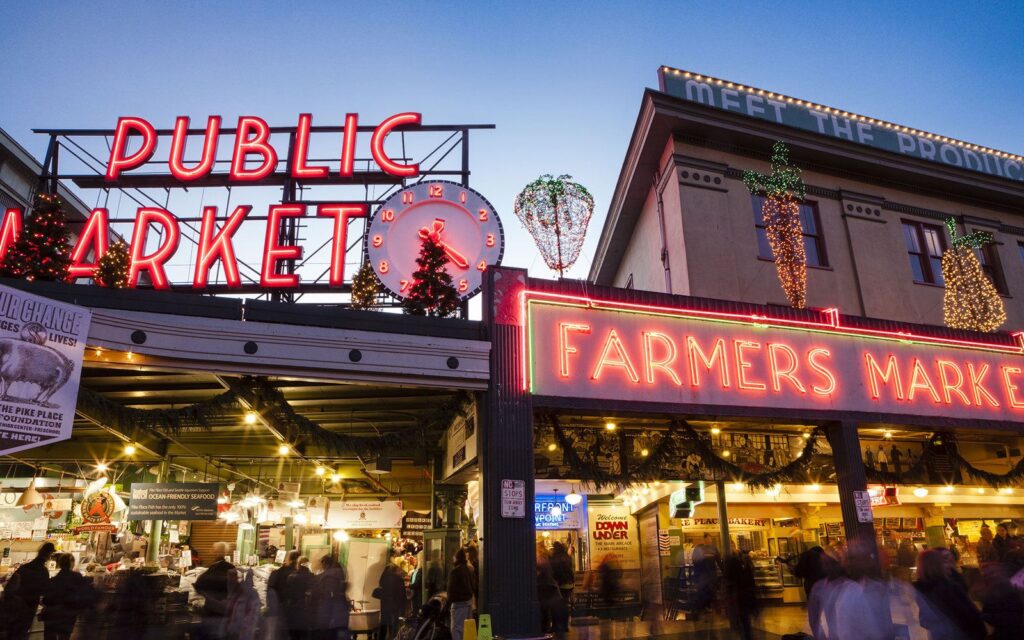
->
[[0, 285, 92, 455]]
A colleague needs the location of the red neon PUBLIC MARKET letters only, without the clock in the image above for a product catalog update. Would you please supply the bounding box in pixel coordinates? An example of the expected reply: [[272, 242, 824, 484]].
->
[[0, 112, 422, 290]]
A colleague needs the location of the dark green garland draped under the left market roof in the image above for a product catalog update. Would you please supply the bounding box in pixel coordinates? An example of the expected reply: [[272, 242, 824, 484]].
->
[[77, 377, 467, 458]]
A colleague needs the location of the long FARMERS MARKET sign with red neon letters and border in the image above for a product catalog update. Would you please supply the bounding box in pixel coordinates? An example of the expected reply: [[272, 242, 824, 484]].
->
[[520, 291, 1024, 423]]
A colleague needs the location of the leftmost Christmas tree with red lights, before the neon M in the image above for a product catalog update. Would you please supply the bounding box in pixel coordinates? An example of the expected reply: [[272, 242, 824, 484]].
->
[[0, 189, 71, 282]]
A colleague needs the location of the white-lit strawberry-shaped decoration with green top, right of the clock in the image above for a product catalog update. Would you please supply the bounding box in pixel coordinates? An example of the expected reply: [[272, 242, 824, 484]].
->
[[515, 174, 594, 278]]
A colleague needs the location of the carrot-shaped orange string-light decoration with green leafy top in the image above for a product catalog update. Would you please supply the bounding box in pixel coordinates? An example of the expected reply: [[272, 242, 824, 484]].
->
[[743, 142, 807, 309]]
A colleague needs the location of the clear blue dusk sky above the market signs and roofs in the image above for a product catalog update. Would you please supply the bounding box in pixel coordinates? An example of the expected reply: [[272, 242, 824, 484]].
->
[[0, 0, 1024, 276]]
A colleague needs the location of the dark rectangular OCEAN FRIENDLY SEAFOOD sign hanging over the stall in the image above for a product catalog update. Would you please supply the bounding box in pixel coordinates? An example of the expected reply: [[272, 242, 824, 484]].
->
[[128, 482, 219, 520]]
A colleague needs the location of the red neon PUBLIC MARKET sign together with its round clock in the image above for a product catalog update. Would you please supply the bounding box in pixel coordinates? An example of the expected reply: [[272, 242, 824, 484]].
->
[[8, 112, 504, 298]]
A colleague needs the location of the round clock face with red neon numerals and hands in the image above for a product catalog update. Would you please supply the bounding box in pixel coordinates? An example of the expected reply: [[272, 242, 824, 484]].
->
[[366, 181, 505, 300]]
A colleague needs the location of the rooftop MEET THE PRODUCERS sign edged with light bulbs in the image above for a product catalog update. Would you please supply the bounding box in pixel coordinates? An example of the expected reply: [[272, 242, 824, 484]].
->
[[658, 67, 1024, 181]]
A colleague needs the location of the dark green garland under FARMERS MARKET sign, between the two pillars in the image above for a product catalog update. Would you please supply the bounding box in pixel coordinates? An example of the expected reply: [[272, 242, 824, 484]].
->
[[547, 415, 823, 488]]
